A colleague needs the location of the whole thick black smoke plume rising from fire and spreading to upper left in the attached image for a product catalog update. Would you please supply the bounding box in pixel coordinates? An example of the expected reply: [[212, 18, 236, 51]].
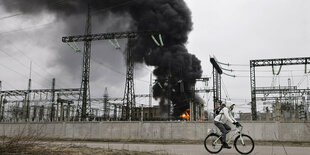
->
[[2, 0, 202, 117]]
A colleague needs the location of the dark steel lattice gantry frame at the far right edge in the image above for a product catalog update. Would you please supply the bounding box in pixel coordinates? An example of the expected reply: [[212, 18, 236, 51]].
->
[[250, 57, 310, 120]]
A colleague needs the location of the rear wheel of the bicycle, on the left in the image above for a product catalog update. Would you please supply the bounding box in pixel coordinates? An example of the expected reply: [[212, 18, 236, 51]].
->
[[204, 133, 223, 154]]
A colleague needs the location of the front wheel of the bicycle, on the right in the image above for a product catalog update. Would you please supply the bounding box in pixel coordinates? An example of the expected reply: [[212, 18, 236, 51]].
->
[[234, 134, 254, 154]]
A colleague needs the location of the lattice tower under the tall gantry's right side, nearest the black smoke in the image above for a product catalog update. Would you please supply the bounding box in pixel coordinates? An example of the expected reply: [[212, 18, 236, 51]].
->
[[122, 40, 136, 121]]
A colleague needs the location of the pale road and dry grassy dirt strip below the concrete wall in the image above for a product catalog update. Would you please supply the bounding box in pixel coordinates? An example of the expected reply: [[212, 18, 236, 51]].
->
[[0, 135, 310, 155]]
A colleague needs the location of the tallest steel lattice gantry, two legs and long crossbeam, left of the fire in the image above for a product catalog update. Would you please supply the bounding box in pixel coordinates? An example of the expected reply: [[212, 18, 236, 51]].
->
[[62, 12, 158, 120]]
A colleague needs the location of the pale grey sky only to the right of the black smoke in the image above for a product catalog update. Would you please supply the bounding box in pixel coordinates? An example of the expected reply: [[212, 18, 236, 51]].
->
[[186, 0, 310, 111]]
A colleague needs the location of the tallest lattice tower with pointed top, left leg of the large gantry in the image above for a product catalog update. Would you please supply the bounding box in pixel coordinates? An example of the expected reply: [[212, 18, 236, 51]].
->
[[79, 6, 91, 121]]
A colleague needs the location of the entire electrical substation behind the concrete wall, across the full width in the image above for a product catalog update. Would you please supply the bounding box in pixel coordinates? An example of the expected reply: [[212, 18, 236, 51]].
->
[[0, 7, 310, 122]]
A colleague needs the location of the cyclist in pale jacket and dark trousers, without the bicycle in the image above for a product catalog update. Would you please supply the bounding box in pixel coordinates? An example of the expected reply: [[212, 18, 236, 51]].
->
[[214, 104, 241, 149]]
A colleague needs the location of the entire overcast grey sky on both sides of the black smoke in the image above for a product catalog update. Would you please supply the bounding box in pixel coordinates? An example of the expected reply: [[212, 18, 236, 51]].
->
[[0, 0, 310, 111]]
